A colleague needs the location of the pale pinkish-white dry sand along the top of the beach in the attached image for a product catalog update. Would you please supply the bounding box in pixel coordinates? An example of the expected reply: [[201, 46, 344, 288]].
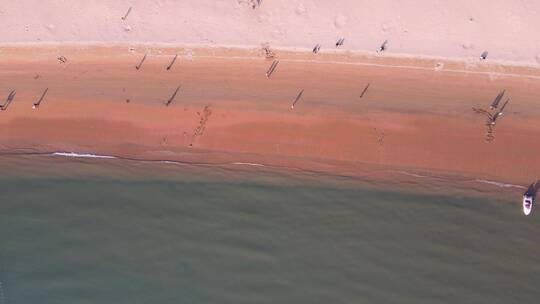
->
[[0, 0, 540, 65]]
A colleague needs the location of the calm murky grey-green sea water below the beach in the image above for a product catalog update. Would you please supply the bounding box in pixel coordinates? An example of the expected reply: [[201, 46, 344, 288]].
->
[[0, 159, 540, 304]]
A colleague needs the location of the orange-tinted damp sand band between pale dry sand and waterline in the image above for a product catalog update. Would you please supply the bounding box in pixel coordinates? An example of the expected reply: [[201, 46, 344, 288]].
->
[[0, 47, 540, 184]]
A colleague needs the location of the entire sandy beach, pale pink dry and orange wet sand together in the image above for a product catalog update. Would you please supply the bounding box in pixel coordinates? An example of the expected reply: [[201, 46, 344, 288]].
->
[[0, 0, 540, 188]]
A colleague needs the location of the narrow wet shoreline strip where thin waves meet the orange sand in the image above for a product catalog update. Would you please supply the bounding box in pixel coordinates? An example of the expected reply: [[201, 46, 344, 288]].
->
[[0, 151, 526, 202]]
